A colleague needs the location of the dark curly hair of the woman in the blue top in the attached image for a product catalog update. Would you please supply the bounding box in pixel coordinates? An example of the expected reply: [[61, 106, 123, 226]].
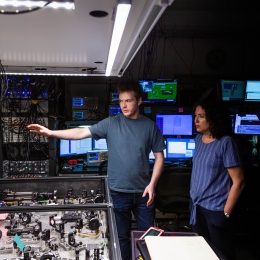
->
[[193, 99, 232, 139]]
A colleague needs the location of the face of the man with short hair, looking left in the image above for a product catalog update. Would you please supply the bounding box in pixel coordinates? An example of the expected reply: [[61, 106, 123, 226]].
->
[[119, 91, 142, 119]]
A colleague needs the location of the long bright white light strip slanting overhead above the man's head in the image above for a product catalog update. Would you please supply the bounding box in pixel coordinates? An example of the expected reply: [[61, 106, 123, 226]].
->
[[106, 3, 131, 76]]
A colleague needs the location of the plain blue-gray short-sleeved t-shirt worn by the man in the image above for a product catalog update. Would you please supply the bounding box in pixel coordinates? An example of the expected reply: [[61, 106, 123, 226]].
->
[[89, 114, 165, 193]]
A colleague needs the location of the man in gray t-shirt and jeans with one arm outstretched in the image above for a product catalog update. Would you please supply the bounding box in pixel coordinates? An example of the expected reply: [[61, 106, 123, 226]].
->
[[28, 80, 165, 260]]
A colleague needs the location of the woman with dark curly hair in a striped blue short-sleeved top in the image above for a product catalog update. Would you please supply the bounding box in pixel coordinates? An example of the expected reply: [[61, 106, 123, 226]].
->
[[190, 100, 245, 260]]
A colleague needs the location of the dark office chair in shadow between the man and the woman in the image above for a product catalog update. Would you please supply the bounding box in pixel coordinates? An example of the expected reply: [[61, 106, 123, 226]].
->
[[155, 167, 191, 232]]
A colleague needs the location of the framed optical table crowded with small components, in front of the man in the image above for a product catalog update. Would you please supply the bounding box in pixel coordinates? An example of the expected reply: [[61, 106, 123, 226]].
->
[[0, 176, 121, 260]]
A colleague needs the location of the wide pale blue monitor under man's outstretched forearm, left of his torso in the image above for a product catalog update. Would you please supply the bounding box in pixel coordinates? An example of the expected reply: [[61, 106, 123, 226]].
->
[[60, 138, 92, 157]]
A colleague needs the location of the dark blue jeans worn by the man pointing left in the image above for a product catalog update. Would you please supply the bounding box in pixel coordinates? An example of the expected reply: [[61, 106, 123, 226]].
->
[[111, 191, 155, 260]]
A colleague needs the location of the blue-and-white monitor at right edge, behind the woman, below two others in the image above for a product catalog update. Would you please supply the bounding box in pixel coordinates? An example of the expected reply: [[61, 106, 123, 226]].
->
[[234, 114, 260, 135]]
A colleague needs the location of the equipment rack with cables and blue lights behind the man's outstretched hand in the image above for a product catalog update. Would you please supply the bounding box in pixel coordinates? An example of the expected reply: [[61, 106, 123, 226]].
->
[[0, 75, 56, 178]]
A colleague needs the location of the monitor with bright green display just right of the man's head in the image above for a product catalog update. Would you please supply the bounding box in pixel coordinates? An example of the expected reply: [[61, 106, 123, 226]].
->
[[139, 79, 177, 103]]
